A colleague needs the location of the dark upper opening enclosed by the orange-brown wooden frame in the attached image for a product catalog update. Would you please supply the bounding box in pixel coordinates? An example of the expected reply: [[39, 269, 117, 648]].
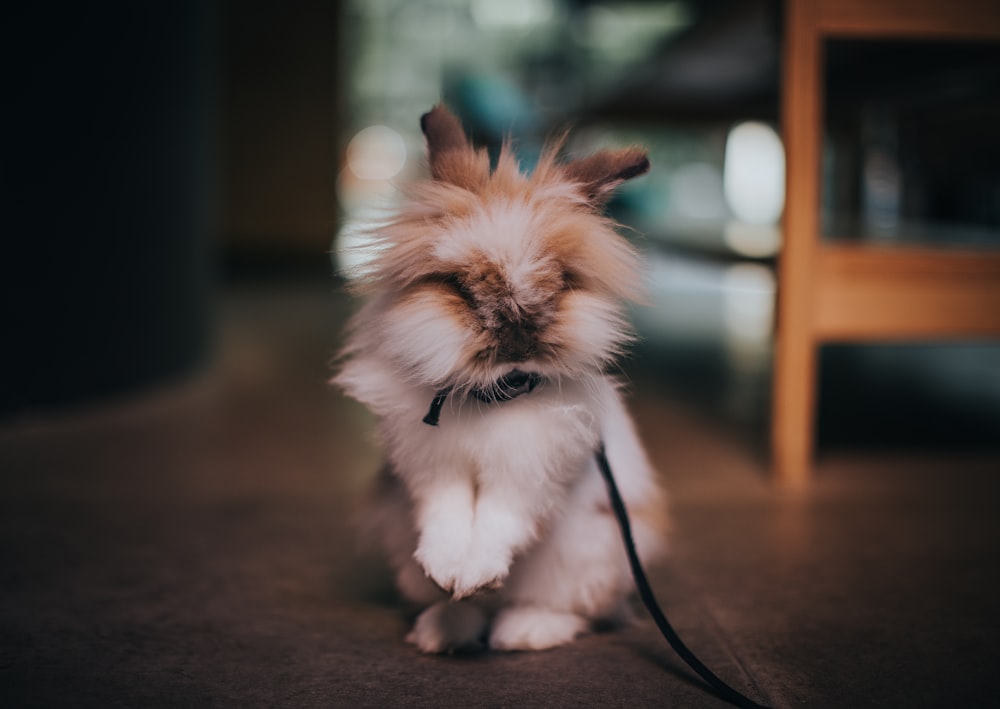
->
[[822, 40, 1000, 247]]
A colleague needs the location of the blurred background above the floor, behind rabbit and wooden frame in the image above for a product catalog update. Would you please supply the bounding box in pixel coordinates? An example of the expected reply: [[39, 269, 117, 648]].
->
[[0, 0, 1000, 446]]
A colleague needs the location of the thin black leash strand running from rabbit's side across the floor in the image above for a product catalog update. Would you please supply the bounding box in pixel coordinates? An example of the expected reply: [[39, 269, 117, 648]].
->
[[594, 442, 767, 709]]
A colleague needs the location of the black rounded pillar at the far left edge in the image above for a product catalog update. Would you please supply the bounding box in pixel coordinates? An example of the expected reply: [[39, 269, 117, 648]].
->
[[0, 0, 218, 417]]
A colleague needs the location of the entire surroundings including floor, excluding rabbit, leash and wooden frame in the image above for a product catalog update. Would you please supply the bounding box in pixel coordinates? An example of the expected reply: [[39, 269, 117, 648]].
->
[[0, 0, 1000, 708]]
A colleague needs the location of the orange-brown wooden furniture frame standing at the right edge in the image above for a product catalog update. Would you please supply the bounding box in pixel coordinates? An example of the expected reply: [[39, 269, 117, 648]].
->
[[771, 0, 1000, 484]]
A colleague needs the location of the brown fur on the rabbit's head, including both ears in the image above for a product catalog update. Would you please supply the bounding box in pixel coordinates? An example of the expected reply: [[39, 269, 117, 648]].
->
[[352, 106, 648, 377]]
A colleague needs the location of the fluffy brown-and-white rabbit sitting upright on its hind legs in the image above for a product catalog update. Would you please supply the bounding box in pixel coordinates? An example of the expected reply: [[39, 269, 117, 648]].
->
[[333, 105, 666, 653]]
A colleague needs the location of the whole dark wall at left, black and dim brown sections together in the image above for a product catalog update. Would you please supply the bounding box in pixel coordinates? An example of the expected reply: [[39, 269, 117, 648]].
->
[[0, 0, 341, 418]]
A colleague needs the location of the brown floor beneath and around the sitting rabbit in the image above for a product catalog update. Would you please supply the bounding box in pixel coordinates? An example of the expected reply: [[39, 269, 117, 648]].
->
[[0, 280, 1000, 707]]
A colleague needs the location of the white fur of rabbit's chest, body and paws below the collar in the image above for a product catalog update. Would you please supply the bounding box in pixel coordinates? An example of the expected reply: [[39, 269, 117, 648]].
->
[[337, 359, 662, 652]]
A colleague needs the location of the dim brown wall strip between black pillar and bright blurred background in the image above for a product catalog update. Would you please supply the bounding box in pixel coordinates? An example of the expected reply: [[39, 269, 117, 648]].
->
[[221, 0, 342, 254]]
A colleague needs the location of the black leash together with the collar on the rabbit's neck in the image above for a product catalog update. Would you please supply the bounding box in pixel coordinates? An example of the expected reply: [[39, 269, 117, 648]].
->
[[423, 384, 768, 709]]
